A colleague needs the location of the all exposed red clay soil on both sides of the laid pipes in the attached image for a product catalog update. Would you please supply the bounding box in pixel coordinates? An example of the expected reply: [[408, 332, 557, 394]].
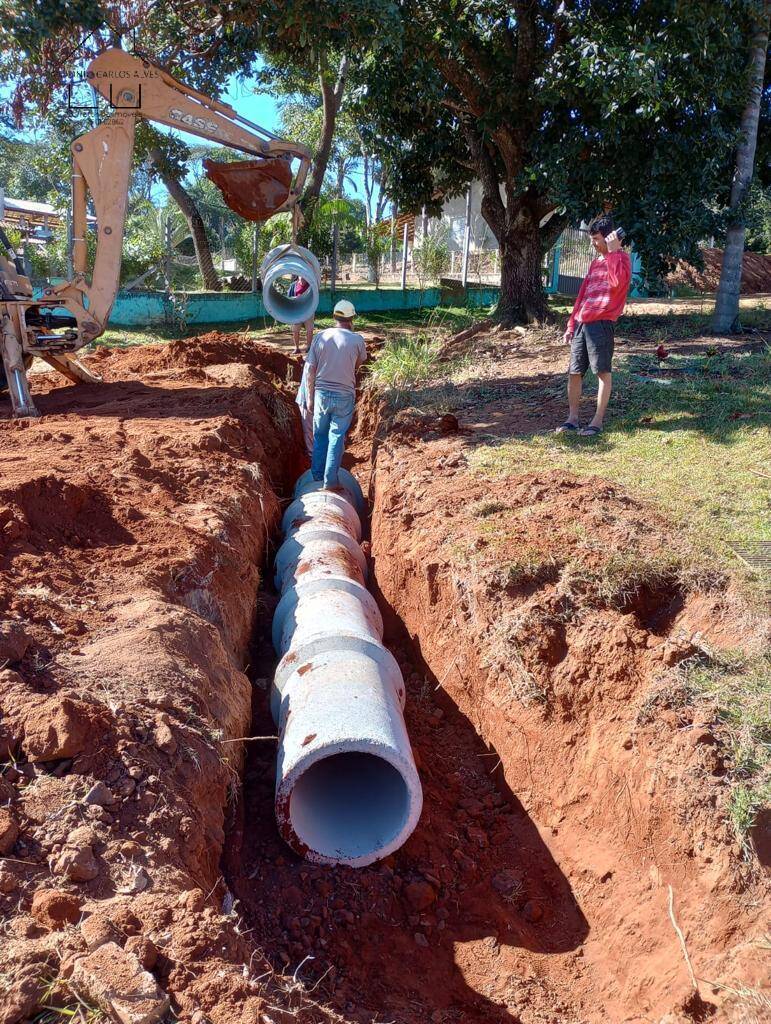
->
[[0, 323, 764, 1024]]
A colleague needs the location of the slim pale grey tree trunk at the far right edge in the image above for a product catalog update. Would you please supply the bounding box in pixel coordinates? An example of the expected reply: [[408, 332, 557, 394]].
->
[[712, 0, 771, 334]]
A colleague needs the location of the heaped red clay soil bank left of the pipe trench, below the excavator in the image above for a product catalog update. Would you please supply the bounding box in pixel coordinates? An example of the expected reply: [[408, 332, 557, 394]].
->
[[0, 335, 333, 1024]]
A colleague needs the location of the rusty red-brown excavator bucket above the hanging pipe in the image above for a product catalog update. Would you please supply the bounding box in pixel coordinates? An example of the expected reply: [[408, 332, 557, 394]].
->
[[204, 157, 292, 220]]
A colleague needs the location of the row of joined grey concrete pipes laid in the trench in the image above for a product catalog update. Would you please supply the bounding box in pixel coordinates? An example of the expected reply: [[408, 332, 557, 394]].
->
[[271, 470, 423, 867]]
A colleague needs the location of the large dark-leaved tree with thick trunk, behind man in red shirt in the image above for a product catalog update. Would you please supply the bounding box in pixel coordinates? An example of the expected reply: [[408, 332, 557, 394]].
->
[[360, 0, 757, 319]]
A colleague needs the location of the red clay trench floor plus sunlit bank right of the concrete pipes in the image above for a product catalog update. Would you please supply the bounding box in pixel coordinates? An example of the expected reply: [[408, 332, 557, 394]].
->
[[225, 327, 765, 1024]]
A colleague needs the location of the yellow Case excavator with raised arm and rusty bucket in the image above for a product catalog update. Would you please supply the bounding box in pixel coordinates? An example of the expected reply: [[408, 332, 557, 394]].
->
[[0, 49, 310, 417]]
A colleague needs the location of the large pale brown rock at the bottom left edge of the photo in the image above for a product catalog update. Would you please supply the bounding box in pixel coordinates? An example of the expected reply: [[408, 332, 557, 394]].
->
[[70, 942, 169, 1024]]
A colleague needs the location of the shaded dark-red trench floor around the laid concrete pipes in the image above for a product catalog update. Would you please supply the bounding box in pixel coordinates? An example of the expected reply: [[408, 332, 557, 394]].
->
[[224, 452, 590, 1024]]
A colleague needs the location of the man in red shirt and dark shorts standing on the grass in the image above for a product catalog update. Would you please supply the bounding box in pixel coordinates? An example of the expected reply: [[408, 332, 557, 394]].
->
[[557, 216, 632, 437]]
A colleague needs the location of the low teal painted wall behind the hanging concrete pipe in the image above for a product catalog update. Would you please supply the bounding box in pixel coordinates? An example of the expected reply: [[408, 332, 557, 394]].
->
[[110, 288, 498, 327]]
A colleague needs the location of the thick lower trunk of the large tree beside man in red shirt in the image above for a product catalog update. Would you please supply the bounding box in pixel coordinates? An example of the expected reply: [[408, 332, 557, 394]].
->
[[496, 225, 547, 327]]
